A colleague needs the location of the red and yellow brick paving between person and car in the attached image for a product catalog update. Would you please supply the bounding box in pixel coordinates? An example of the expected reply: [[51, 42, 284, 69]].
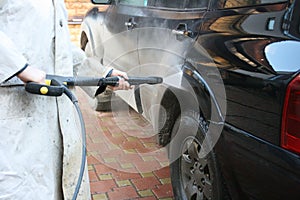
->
[[77, 89, 173, 200]]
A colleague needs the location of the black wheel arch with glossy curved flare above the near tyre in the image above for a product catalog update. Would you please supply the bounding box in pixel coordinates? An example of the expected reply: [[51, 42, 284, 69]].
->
[[158, 64, 224, 146]]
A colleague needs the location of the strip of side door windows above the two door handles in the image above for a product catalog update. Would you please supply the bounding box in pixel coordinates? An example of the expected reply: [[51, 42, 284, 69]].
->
[[118, 0, 209, 9]]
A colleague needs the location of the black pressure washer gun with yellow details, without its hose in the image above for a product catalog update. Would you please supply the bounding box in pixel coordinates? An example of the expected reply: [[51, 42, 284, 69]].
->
[[25, 75, 163, 96]]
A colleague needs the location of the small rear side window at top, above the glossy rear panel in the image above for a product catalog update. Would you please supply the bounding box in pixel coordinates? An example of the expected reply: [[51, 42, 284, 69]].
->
[[220, 0, 286, 8]]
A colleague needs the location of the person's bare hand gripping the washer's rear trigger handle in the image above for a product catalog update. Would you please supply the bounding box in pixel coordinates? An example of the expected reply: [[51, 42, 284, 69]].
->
[[17, 66, 46, 84]]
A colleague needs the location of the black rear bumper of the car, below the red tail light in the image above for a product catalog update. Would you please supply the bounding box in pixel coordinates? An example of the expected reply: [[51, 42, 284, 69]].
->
[[217, 124, 300, 200]]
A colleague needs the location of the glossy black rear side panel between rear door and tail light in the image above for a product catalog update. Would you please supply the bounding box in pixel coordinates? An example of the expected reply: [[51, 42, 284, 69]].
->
[[198, 0, 290, 145]]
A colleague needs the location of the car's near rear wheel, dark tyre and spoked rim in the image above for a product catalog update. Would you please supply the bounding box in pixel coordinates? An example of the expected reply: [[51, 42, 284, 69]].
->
[[169, 111, 224, 200]]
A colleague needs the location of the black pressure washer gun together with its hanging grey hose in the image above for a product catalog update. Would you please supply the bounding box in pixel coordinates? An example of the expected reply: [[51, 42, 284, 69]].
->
[[25, 75, 163, 200]]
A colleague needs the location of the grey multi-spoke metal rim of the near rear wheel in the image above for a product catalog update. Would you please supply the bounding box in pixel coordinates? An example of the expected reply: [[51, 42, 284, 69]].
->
[[180, 137, 212, 200]]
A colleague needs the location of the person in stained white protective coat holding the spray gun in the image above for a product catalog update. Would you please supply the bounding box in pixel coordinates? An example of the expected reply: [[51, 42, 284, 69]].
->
[[0, 0, 129, 200]]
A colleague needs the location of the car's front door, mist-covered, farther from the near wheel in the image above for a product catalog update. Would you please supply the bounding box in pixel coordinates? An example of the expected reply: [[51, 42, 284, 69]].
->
[[101, 0, 140, 110]]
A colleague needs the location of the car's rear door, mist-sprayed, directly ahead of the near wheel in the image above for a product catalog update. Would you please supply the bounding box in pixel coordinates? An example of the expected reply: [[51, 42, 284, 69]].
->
[[113, 0, 208, 123]]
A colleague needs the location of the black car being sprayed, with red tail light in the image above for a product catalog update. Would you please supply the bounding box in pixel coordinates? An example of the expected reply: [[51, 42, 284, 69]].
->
[[81, 0, 300, 200]]
